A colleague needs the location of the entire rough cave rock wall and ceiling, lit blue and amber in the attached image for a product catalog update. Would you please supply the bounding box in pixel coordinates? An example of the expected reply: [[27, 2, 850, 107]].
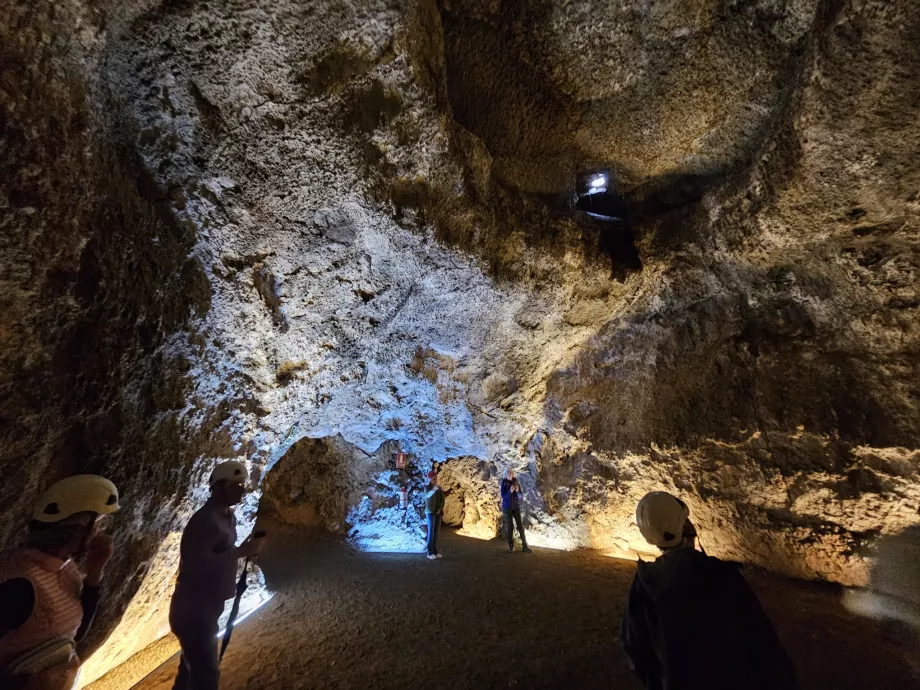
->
[[0, 0, 920, 680]]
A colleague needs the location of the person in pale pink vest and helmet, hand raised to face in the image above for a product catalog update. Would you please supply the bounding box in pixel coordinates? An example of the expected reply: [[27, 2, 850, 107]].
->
[[0, 474, 119, 690]]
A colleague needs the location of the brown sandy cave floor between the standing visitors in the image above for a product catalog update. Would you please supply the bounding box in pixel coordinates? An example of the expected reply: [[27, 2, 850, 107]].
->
[[135, 528, 917, 690]]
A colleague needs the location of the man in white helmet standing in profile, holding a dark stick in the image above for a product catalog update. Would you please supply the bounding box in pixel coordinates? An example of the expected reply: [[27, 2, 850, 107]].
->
[[169, 460, 261, 690]]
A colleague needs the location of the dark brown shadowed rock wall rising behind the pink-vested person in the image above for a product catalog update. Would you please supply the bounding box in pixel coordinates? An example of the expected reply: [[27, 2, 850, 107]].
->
[[0, 2, 255, 684]]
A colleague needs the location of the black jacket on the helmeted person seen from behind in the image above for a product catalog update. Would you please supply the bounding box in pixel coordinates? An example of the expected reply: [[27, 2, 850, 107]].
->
[[622, 549, 798, 690]]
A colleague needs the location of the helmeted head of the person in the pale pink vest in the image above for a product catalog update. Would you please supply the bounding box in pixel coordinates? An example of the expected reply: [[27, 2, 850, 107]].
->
[[28, 474, 119, 560]]
